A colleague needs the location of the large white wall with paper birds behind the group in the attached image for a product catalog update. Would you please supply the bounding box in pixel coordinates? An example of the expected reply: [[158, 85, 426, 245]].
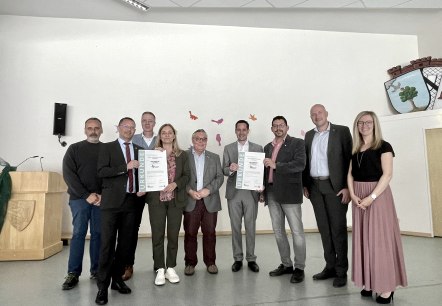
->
[[0, 16, 418, 232]]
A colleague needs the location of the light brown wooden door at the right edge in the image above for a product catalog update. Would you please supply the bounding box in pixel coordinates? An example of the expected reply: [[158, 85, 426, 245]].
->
[[425, 129, 442, 237]]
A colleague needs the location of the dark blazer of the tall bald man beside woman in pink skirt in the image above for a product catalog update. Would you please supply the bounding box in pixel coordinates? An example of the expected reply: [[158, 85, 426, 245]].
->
[[302, 123, 353, 193]]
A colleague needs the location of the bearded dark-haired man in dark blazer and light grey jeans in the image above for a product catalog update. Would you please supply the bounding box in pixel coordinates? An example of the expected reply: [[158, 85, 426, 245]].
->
[[264, 116, 306, 283]]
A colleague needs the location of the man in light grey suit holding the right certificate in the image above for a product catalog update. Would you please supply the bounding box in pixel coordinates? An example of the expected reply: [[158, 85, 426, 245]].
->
[[223, 120, 263, 272]]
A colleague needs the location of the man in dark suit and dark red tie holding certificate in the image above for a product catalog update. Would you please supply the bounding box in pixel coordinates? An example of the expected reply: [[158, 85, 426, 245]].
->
[[95, 117, 144, 305]]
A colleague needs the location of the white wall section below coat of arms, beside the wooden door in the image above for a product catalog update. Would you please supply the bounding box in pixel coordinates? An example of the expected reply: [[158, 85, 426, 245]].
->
[[380, 110, 442, 235]]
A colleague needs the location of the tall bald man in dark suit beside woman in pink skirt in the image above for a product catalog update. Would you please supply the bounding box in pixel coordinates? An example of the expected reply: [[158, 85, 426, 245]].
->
[[303, 104, 352, 287]]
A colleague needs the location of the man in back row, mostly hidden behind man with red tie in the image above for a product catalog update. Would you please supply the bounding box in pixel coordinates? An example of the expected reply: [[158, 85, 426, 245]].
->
[[123, 112, 157, 281]]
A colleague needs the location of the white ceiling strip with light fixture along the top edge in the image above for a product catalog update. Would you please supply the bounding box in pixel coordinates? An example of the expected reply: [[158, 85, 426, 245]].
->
[[0, 0, 442, 20]]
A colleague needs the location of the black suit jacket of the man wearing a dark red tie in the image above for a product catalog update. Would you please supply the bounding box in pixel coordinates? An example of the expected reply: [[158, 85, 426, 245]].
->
[[97, 140, 142, 210]]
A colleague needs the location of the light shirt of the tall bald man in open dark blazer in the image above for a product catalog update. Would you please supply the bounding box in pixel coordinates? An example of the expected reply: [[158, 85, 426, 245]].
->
[[310, 123, 330, 177]]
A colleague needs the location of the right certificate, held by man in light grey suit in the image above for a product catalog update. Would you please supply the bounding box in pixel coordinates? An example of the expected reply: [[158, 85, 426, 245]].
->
[[236, 152, 265, 190]]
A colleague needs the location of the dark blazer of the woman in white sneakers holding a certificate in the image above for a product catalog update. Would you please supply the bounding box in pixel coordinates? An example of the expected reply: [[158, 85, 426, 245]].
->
[[146, 152, 190, 208]]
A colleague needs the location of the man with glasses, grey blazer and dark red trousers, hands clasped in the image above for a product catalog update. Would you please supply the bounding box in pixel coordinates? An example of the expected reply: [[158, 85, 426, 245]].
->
[[184, 129, 224, 275]]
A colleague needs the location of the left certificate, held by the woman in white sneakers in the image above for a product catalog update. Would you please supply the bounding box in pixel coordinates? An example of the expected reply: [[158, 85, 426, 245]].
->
[[138, 150, 169, 192]]
